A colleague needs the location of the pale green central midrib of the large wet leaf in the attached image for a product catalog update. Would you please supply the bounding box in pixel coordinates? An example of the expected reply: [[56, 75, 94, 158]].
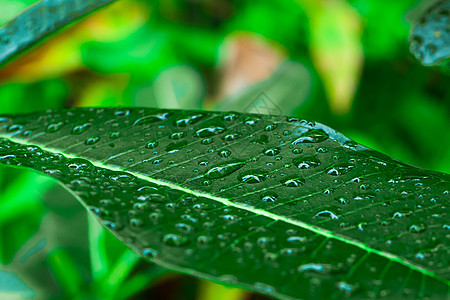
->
[[0, 134, 450, 285]]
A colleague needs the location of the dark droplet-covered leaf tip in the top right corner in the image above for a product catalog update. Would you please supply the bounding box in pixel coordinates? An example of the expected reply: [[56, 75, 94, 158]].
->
[[410, 0, 450, 66]]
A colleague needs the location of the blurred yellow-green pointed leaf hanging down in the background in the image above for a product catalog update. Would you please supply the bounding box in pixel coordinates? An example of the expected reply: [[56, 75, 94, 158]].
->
[[298, 0, 364, 115]]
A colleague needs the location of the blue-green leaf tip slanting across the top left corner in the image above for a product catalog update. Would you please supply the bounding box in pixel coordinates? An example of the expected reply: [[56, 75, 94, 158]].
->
[[0, 0, 118, 64]]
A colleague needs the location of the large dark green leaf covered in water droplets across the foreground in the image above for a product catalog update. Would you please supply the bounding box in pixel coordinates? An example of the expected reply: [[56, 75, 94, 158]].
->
[[0, 108, 450, 299]]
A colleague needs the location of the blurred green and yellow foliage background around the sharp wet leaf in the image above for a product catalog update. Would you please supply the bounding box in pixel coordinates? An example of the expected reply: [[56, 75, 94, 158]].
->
[[0, 0, 450, 300]]
